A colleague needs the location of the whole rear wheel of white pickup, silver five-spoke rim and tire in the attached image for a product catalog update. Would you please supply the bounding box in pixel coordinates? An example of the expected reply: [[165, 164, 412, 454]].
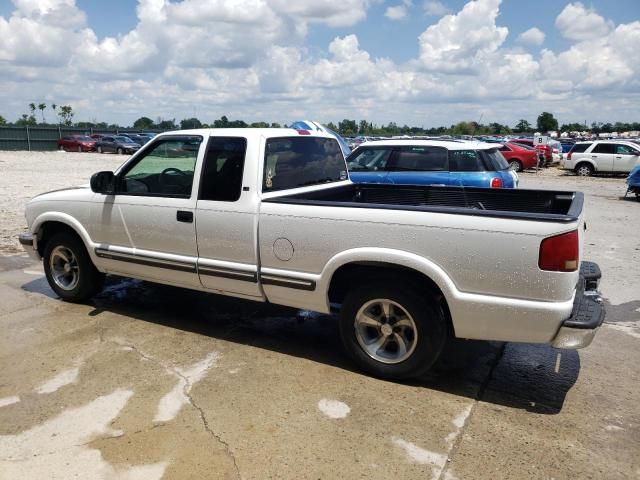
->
[[340, 282, 447, 380]]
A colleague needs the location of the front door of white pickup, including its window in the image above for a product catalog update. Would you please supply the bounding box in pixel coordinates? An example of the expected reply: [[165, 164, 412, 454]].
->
[[92, 135, 202, 287]]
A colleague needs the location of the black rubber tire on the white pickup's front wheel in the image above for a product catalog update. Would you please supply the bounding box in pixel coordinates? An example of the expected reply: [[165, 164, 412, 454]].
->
[[43, 232, 105, 302]]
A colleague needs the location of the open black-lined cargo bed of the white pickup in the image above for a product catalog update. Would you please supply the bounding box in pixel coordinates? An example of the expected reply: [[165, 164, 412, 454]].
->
[[263, 184, 584, 223]]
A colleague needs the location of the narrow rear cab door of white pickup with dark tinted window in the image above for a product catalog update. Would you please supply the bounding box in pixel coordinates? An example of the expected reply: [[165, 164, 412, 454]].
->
[[196, 137, 262, 298]]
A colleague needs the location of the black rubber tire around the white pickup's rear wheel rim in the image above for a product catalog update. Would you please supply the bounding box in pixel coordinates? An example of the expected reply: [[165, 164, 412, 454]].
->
[[340, 280, 448, 380]]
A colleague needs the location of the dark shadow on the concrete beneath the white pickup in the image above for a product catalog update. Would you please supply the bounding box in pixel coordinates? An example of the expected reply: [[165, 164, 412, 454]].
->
[[23, 277, 580, 414]]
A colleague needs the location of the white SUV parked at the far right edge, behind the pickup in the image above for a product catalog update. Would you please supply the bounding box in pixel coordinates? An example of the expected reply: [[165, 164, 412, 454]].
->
[[560, 140, 640, 177]]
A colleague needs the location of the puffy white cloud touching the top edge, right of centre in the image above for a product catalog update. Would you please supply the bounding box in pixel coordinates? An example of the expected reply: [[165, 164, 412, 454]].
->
[[419, 0, 509, 72]]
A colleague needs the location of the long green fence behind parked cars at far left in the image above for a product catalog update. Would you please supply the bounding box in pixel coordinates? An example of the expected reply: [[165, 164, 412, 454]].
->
[[0, 126, 159, 151]]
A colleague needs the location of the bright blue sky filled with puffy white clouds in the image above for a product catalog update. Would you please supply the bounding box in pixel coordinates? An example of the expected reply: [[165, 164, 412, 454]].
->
[[0, 0, 640, 126]]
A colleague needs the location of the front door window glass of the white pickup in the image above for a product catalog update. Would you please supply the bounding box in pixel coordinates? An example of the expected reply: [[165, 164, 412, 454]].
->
[[117, 136, 202, 198]]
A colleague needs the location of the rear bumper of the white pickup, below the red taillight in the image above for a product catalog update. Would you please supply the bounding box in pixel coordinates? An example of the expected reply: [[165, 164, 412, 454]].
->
[[551, 262, 605, 350]]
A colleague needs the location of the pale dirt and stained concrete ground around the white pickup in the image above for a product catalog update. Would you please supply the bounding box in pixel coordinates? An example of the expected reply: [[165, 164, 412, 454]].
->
[[0, 152, 640, 480]]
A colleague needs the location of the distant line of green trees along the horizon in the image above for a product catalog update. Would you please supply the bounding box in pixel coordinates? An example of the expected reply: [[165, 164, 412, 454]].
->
[[0, 103, 640, 137]]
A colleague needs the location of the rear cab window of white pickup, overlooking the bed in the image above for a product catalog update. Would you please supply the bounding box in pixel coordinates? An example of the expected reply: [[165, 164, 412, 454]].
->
[[262, 136, 347, 192]]
